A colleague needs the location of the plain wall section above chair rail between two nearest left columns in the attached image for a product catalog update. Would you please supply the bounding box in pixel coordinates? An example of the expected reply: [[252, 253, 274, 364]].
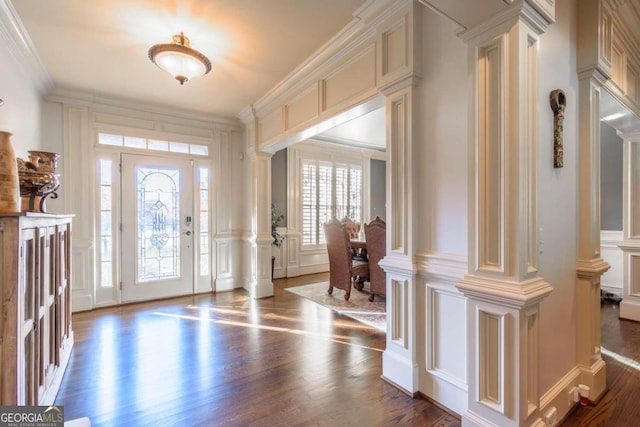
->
[[416, 8, 469, 255]]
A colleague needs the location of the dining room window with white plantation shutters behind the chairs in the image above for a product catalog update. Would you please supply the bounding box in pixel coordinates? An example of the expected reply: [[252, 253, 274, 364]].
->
[[301, 159, 362, 245]]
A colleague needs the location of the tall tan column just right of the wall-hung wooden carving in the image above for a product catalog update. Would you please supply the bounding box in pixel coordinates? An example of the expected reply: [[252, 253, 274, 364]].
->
[[576, 0, 612, 400]]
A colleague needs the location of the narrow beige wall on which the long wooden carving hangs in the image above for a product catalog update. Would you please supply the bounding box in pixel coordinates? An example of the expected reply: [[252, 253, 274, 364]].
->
[[537, 1, 578, 394]]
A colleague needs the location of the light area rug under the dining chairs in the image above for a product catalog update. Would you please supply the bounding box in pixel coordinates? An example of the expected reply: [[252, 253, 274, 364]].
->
[[285, 282, 387, 332]]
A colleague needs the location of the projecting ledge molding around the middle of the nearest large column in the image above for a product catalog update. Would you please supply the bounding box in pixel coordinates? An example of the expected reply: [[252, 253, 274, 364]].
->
[[456, 275, 553, 309]]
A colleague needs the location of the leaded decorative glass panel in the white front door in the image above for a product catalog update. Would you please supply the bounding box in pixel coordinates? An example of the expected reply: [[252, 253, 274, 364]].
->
[[136, 167, 181, 282]]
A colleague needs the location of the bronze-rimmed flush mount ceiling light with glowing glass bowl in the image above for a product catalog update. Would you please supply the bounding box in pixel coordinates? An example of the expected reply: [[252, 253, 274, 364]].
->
[[149, 33, 211, 85]]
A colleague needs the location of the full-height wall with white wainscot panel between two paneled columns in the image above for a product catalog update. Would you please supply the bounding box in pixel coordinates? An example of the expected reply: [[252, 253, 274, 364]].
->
[[412, 8, 469, 414]]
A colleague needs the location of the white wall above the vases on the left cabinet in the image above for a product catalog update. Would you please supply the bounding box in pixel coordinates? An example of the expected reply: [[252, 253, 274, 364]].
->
[[0, 33, 42, 158]]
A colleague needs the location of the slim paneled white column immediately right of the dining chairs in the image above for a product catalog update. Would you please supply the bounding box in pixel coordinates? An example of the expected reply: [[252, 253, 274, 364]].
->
[[380, 77, 420, 395]]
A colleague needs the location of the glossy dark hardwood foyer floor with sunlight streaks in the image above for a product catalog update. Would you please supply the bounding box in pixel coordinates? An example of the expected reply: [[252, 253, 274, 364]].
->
[[56, 275, 460, 427]]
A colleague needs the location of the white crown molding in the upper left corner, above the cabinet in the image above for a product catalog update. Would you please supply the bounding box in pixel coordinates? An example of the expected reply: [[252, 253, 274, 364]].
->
[[0, 0, 54, 93]]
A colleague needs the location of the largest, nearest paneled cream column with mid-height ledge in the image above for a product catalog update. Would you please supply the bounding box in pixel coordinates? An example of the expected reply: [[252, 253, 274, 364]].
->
[[458, 7, 552, 426]]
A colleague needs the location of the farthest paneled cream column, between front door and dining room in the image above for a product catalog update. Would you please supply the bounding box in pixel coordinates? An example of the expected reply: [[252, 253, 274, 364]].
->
[[246, 152, 273, 298]]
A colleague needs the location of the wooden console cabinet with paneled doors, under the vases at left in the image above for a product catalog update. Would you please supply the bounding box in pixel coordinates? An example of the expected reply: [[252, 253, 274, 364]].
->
[[0, 213, 73, 405]]
